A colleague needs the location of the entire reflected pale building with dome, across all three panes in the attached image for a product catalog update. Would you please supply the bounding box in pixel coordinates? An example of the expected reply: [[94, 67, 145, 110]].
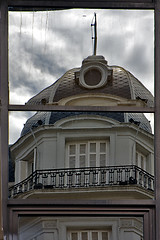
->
[[9, 56, 154, 240]]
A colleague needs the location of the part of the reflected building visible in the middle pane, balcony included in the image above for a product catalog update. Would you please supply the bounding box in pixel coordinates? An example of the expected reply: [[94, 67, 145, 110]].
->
[[9, 112, 154, 200]]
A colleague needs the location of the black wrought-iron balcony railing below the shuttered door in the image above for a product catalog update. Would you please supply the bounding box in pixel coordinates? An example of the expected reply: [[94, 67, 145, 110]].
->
[[9, 165, 154, 198]]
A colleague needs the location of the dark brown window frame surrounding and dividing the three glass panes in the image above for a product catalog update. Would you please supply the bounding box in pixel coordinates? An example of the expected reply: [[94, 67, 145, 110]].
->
[[0, 0, 160, 240]]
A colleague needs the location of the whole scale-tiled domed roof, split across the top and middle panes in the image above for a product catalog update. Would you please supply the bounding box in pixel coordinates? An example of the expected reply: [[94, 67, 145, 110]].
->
[[21, 56, 154, 136]]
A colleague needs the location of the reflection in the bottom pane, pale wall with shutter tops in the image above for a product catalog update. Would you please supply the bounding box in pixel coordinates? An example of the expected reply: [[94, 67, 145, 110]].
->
[[18, 216, 143, 240]]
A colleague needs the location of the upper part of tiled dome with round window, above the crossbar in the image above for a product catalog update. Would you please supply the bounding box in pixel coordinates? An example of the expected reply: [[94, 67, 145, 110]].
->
[[27, 56, 153, 107]]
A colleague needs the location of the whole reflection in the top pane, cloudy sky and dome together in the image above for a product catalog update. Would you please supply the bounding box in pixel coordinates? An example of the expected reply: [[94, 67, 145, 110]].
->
[[9, 9, 154, 106]]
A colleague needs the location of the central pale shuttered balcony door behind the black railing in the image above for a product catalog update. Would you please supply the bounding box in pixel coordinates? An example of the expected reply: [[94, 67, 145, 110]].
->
[[67, 140, 109, 168]]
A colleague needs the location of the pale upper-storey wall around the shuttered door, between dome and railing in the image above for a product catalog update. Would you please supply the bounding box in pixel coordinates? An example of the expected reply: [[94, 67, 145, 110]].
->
[[11, 117, 154, 183]]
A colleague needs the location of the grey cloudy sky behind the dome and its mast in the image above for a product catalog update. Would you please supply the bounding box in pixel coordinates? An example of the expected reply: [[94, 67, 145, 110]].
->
[[9, 9, 154, 143]]
